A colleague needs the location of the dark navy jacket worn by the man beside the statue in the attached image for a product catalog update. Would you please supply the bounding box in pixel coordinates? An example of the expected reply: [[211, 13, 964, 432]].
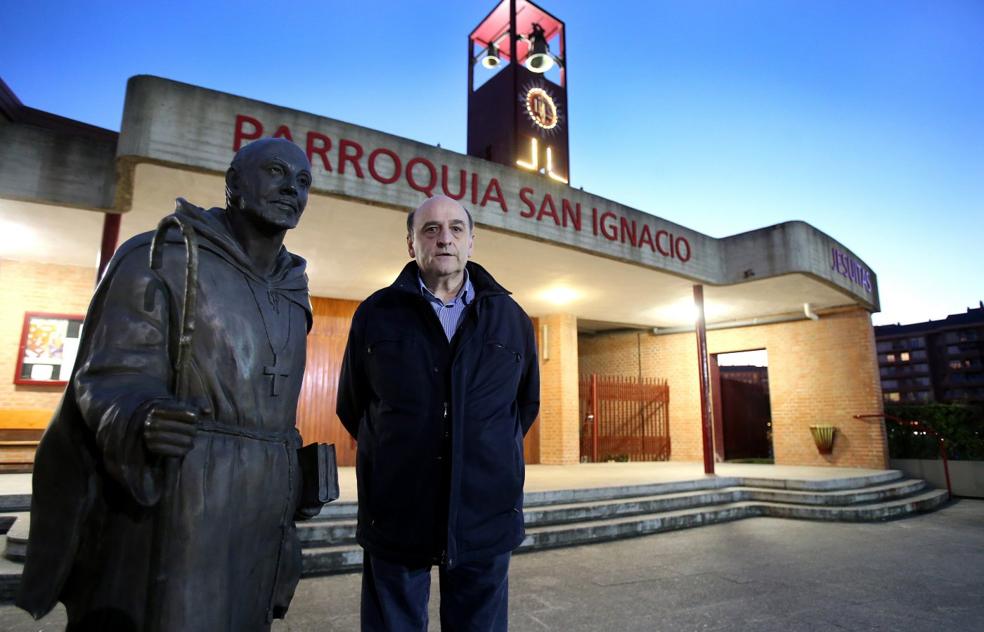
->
[[338, 262, 540, 567]]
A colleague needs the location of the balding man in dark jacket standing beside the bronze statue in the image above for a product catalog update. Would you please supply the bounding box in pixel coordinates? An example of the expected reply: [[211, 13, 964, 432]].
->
[[338, 196, 540, 631]]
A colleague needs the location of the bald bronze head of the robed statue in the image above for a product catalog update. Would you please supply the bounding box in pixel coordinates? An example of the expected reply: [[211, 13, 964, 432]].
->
[[226, 138, 311, 231]]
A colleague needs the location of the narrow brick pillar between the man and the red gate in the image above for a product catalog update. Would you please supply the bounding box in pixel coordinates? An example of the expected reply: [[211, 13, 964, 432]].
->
[[537, 314, 581, 465]]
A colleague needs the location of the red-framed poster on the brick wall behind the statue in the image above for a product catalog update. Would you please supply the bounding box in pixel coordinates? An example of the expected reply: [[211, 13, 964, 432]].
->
[[14, 312, 83, 386]]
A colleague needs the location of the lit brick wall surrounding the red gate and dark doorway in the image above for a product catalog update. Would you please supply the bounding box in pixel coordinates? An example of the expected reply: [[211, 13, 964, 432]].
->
[[578, 309, 888, 468]]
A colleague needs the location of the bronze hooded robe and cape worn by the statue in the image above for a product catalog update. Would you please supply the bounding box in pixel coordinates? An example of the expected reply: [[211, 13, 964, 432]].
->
[[17, 200, 311, 632]]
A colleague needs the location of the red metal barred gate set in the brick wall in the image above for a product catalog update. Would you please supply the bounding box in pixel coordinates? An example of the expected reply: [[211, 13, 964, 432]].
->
[[579, 375, 670, 463]]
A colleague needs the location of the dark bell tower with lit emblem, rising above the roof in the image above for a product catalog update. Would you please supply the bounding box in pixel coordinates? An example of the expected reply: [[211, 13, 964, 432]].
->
[[468, 0, 570, 183]]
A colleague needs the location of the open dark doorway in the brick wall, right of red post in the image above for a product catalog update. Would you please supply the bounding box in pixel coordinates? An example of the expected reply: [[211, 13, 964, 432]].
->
[[713, 349, 773, 462]]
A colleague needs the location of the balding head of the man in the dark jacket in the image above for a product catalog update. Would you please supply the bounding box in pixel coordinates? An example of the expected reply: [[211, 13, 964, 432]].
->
[[407, 197, 474, 277]]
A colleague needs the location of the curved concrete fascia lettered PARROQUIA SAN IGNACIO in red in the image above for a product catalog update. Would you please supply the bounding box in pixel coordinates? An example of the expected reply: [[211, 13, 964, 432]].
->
[[117, 76, 878, 310]]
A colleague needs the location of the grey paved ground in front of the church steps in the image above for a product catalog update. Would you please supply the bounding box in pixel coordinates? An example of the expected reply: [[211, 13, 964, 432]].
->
[[0, 500, 984, 632]]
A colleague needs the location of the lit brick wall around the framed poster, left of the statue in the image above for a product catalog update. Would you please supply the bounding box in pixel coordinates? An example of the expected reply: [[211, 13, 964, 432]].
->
[[0, 259, 96, 411]]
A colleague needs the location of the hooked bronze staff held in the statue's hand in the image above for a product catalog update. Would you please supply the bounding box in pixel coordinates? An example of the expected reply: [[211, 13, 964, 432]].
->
[[144, 213, 198, 630]]
